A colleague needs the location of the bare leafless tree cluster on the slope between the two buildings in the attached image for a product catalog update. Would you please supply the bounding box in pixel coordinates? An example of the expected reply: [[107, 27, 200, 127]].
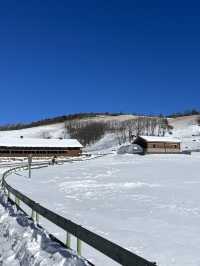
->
[[65, 116, 170, 146]]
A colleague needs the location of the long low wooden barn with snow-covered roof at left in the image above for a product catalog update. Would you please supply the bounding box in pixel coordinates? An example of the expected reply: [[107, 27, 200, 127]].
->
[[0, 137, 82, 157]]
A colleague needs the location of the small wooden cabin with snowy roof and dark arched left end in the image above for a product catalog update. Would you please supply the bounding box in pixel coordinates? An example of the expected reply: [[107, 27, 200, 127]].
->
[[134, 136, 181, 154]]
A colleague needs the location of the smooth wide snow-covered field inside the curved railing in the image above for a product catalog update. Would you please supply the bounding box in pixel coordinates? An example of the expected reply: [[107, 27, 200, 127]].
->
[[5, 153, 200, 266]]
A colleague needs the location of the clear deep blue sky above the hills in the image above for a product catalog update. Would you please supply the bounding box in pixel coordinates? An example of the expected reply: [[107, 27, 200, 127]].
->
[[0, 0, 200, 124]]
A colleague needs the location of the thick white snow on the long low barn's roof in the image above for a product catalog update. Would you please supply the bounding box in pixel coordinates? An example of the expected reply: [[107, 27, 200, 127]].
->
[[0, 137, 83, 148]]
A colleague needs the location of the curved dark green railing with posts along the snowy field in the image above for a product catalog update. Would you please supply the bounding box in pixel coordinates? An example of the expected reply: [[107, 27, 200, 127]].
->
[[1, 163, 156, 266]]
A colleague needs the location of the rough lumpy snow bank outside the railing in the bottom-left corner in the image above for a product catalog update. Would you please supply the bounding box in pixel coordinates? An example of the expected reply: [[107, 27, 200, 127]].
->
[[0, 192, 89, 266]]
